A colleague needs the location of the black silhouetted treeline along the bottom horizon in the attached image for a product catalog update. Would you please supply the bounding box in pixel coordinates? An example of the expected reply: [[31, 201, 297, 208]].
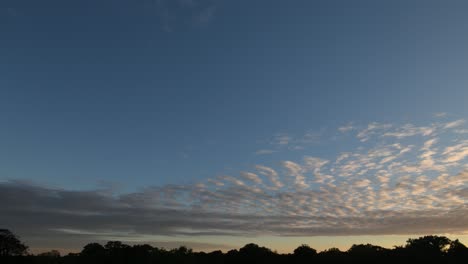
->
[[0, 229, 468, 264]]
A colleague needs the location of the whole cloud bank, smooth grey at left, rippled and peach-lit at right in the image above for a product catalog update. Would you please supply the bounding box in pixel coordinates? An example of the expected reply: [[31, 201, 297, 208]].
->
[[0, 120, 468, 249]]
